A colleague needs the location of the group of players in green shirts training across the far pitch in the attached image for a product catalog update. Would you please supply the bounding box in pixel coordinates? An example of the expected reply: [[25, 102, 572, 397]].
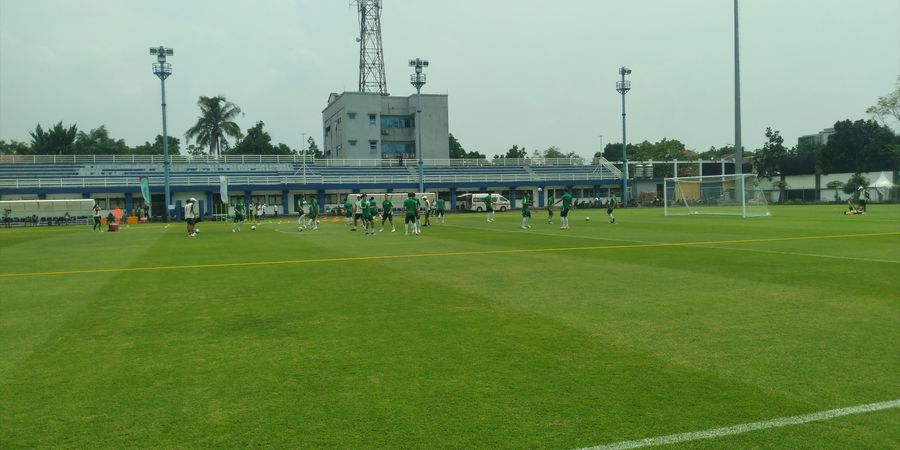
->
[[225, 191, 619, 236]]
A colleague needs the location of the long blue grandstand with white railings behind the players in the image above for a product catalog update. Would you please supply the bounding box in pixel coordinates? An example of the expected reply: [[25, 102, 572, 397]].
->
[[0, 155, 622, 221]]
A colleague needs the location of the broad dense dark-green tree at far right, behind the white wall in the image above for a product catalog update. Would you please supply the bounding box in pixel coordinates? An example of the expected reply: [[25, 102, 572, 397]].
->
[[820, 120, 900, 173]]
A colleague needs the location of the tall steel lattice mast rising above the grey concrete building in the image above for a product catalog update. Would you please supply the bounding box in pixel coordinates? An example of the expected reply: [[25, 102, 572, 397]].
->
[[350, 0, 387, 95]]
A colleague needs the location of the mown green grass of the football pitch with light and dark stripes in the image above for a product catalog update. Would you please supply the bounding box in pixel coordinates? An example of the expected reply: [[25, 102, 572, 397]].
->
[[0, 205, 900, 449]]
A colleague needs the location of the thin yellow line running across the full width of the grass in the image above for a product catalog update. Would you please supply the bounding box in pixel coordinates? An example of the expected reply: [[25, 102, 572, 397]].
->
[[0, 232, 900, 278]]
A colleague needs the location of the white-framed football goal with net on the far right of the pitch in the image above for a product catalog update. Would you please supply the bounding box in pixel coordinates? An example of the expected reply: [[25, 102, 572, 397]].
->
[[663, 174, 771, 217]]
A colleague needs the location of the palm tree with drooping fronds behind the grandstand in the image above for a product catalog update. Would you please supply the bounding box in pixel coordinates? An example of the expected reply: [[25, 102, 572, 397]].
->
[[184, 95, 242, 155]]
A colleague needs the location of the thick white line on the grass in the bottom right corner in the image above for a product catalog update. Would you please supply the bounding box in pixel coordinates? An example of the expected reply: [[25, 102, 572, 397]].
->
[[580, 399, 900, 450]]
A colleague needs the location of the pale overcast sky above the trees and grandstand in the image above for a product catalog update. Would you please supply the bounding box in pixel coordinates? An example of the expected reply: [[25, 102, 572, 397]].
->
[[0, 0, 900, 160]]
